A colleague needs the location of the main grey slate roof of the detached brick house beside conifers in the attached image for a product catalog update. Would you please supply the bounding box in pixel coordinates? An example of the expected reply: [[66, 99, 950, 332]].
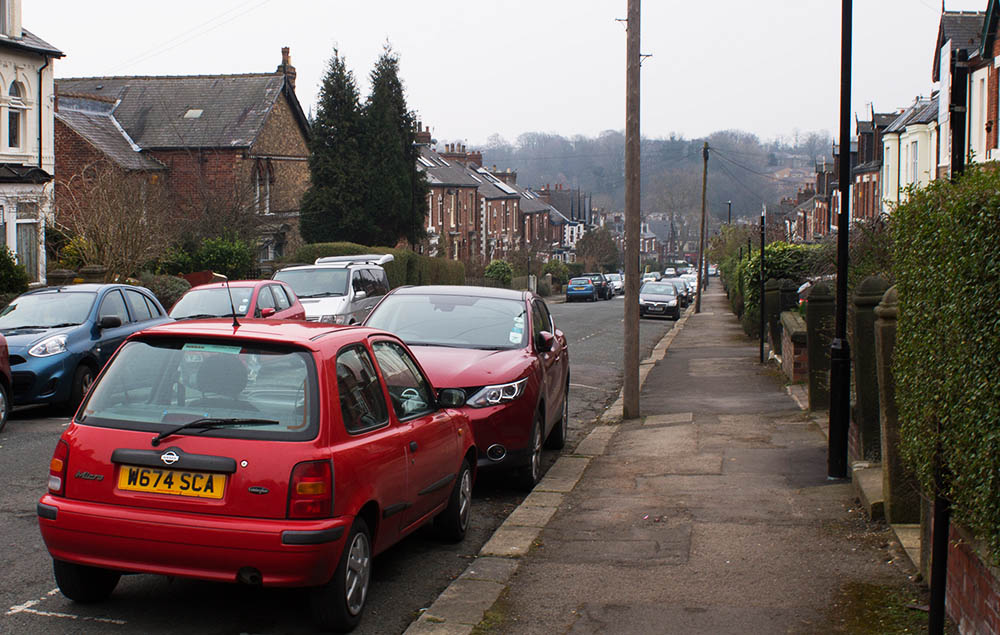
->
[[56, 73, 300, 149]]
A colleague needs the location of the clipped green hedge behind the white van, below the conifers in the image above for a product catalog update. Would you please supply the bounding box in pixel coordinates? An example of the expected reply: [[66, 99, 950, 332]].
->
[[295, 242, 465, 287]]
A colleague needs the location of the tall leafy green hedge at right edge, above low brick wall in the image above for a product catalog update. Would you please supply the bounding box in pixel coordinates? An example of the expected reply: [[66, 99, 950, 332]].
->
[[892, 164, 1000, 562]]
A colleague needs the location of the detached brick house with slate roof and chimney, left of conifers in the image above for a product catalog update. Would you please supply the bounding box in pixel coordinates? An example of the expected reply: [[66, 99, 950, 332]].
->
[[55, 48, 310, 261]]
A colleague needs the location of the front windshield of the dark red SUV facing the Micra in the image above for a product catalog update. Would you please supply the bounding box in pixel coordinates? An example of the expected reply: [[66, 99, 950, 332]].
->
[[365, 294, 528, 350]]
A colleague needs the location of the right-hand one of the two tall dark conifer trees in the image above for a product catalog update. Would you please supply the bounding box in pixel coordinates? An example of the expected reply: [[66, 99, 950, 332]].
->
[[362, 44, 428, 246]]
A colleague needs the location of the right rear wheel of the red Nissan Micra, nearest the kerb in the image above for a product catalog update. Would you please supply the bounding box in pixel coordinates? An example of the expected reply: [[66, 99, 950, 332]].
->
[[310, 517, 372, 632]]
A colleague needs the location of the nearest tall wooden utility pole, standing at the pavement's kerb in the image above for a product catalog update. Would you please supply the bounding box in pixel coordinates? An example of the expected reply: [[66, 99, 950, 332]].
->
[[622, 0, 641, 419]]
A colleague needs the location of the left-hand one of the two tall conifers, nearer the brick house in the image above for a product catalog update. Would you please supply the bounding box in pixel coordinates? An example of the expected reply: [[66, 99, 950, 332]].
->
[[299, 49, 378, 244]]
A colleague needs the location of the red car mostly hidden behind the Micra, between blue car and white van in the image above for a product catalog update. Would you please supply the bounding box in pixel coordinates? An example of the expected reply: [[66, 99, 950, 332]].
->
[[170, 280, 306, 320]]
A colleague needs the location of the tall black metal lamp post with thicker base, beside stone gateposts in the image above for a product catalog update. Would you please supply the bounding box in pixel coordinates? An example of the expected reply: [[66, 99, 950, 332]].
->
[[826, 0, 854, 478]]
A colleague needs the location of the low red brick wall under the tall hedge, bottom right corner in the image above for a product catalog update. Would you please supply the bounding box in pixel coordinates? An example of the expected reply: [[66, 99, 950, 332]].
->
[[946, 524, 1000, 635]]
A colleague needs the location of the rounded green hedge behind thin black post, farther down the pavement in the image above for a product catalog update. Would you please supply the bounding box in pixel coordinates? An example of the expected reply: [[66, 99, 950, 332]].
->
[[739, 242, 820, 336]]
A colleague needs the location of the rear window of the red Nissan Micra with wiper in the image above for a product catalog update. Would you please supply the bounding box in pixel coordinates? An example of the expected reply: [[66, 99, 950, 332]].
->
[[79, 338, 318, 440]]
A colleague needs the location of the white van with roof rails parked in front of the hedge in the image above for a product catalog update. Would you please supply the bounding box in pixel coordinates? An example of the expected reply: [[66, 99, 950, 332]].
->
[[273, 254, 392, 324]]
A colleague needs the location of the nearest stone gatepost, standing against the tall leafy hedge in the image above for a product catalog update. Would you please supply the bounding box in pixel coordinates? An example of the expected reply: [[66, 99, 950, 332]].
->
[[874, 287, 920, 523]]
